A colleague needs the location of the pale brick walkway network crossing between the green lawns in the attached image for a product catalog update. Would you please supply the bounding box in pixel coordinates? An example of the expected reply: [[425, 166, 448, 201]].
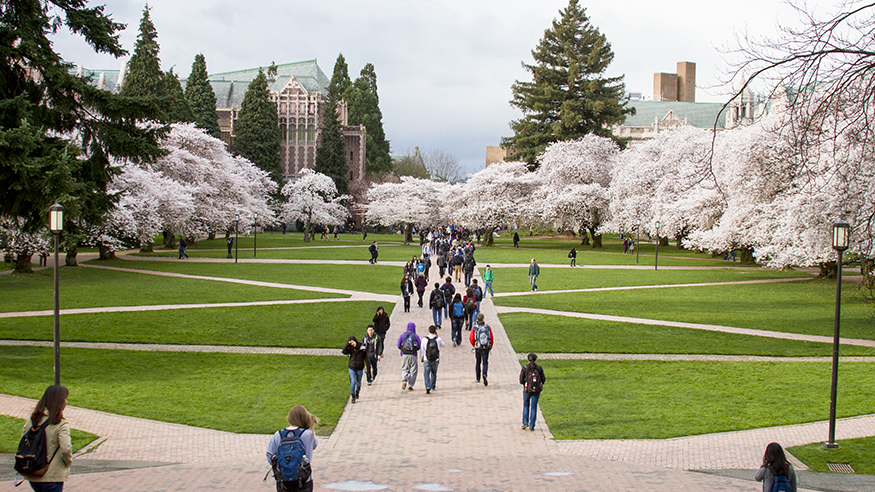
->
[[0, 252, 875, 492]]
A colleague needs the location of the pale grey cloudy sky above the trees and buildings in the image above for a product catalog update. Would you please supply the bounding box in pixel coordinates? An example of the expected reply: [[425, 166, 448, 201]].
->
[[55, 0, 804, 176]]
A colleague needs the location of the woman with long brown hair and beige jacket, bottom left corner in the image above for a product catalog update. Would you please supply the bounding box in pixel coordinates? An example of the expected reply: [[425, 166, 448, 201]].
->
[[16, 385, 73, 492]]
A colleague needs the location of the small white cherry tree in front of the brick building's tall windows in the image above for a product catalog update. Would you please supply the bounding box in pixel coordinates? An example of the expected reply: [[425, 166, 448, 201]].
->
[[281, 169, 352, 242]]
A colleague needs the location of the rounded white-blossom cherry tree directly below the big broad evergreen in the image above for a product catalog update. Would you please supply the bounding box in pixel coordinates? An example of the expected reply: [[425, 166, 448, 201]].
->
[[532, 135, 620, 248]]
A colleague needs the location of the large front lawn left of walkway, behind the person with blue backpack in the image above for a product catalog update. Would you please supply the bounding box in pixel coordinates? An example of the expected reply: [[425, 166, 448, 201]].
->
[[0, 347, 349, 435]]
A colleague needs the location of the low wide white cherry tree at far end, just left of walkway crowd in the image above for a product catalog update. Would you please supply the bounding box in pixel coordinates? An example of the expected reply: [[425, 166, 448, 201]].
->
[[364, 176, 450, 244]]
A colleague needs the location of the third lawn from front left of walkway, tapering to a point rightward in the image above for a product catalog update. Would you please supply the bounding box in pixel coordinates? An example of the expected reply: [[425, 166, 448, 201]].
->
[[0, 262, 338, 312]]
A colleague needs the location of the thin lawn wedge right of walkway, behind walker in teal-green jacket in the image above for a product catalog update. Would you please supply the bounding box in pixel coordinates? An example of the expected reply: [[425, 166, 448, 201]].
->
[[486, 263, 811, 292]]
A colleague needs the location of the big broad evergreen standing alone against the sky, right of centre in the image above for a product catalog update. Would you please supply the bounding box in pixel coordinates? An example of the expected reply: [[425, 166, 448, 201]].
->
[[502, 0, 634, 167]]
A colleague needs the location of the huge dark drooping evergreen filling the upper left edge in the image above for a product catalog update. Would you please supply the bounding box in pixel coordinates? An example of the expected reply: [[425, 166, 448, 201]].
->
[[0, 0, 164, 272]]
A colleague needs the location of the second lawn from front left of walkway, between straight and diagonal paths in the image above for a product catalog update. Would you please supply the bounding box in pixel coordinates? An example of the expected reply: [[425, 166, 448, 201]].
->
[[0, 301, 394, 348]]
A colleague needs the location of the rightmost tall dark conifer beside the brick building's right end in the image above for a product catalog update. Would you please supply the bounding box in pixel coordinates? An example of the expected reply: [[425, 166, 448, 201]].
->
[[346, 63, 392, 174]]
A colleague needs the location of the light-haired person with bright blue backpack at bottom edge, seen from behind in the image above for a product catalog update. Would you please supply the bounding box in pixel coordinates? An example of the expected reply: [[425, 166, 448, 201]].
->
[[267, 405, 319, 492]]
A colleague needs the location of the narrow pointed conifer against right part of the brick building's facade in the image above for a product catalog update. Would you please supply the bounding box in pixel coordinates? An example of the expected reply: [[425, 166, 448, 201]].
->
[[314, 54, 351, 195]]
